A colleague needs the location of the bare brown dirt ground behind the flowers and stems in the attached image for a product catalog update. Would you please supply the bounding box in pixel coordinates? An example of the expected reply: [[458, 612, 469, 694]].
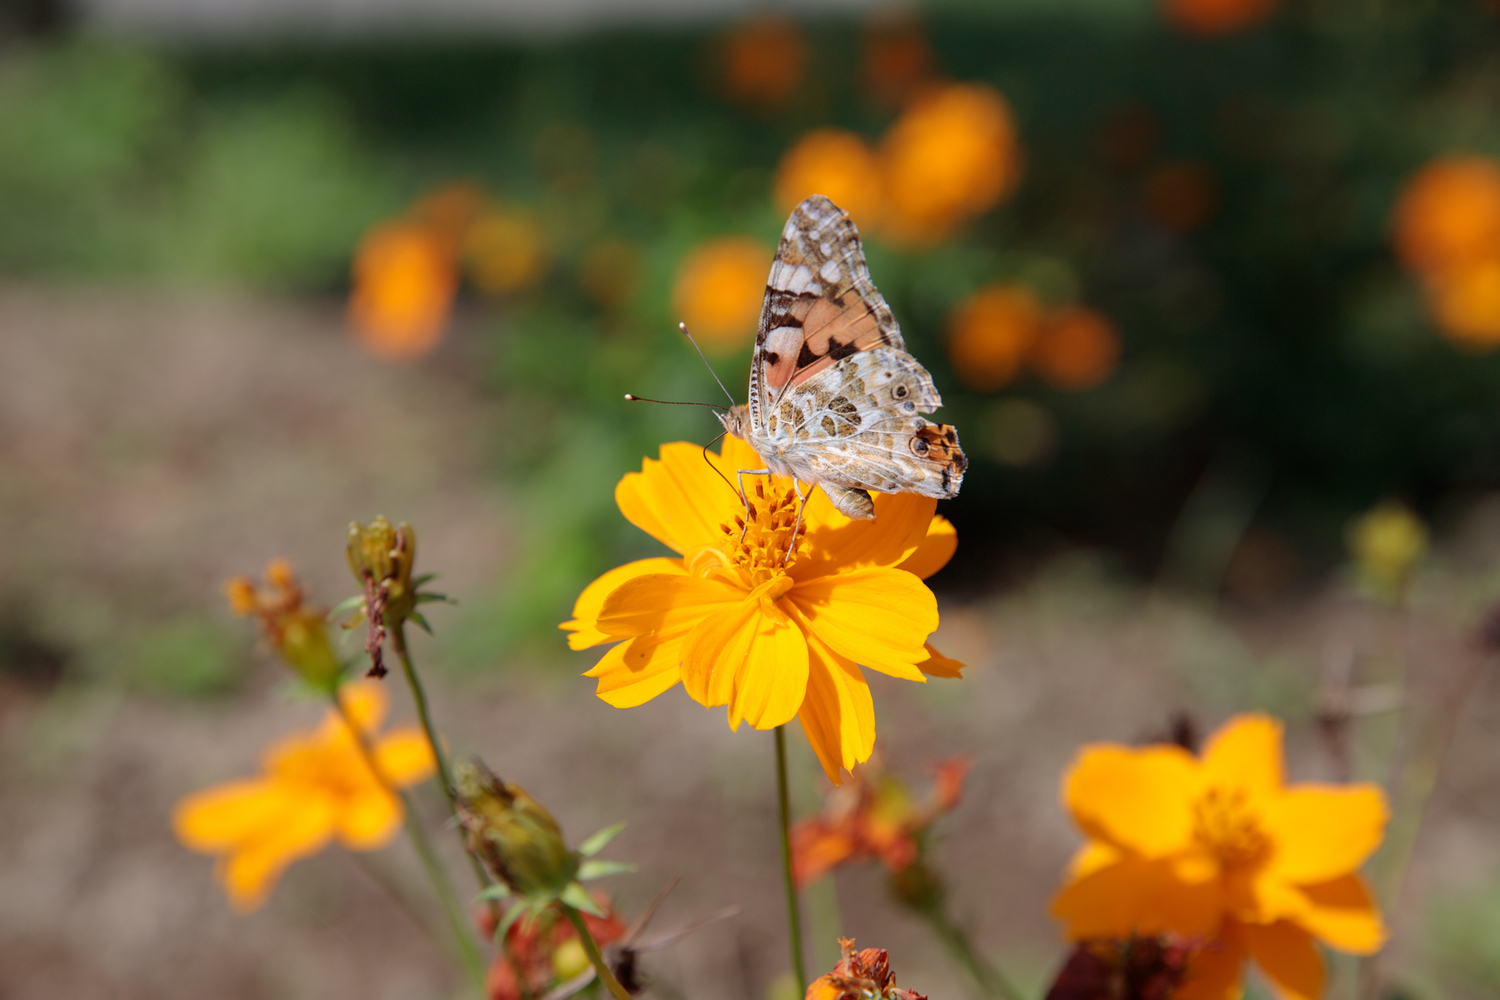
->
[[0, 288, 1500, 1000]]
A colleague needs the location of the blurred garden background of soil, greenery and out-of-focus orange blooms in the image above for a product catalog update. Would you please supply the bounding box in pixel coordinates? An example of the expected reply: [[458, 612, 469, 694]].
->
[[0, 0, 1500, 1000]]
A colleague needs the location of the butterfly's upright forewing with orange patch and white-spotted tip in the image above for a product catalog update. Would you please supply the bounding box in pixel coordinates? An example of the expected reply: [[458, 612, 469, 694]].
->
[[749, 195, 942, 435]]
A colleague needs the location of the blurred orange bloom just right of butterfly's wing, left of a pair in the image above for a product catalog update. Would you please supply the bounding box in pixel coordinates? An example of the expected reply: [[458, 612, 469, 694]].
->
[[948, 285, 1043, 393]]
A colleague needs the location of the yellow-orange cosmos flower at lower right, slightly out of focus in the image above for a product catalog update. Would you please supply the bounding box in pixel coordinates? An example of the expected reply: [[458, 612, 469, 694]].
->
[[1052, 715, 1388, 1000]]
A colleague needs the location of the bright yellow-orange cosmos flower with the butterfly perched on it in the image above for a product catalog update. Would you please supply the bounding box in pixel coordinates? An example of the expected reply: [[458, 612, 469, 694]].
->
[[561, 438, 963, 784]]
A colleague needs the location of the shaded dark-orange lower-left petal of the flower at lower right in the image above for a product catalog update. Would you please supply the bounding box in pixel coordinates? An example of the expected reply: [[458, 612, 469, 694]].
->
[[1052, 856, 1223, 940]]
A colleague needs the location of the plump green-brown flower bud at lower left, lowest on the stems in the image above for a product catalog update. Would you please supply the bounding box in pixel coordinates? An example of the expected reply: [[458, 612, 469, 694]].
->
[[453, 762, 579, 897]]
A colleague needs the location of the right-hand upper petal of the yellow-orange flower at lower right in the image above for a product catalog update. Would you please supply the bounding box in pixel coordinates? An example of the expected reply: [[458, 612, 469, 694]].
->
[[1265, 784, 1391, 882]]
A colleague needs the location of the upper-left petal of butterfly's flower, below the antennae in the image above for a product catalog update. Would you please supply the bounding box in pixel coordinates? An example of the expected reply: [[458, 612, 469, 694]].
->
[[615, 441, 744, 555]]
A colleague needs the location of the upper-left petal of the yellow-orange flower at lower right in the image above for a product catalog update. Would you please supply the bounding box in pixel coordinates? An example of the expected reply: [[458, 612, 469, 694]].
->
[[1062, 744, 1199, 858]]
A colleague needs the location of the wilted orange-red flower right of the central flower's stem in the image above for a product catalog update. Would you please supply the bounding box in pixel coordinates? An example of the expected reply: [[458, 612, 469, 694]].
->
[[792, 757, 971, 886]]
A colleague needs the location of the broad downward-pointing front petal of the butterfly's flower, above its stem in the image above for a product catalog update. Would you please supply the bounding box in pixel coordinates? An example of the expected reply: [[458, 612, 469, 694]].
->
[[681, 601, 807, 729]]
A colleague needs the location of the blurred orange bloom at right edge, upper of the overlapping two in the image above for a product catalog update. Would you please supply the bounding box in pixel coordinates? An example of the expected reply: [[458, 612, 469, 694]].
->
[[1394, 156, 1500, 274]]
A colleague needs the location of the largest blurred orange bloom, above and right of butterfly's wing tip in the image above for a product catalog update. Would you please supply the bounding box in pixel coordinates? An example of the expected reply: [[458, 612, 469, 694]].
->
[[882, 84, 1022, 244]]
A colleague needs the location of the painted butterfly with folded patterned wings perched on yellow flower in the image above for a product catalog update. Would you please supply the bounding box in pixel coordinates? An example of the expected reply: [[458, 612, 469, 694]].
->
[[719, 195, 969, 519]]
